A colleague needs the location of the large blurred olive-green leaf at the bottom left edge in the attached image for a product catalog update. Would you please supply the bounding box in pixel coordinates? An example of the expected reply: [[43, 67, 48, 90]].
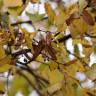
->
[[9, 75, 30, 96]]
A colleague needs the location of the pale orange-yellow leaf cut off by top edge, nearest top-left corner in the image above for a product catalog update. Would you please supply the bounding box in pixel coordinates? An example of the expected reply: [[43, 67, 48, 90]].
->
[[4, 0, 22, 7]]
